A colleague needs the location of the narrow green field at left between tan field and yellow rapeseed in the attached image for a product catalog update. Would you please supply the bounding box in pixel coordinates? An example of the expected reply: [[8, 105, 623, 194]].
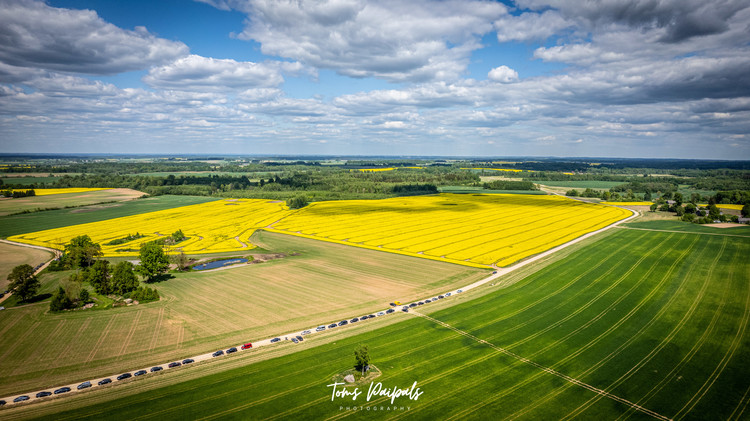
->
[[0, 194, 217, 238]]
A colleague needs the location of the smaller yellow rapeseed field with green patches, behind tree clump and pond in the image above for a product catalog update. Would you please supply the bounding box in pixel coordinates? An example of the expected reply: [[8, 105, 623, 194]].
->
[[9, 199, 289, 256]]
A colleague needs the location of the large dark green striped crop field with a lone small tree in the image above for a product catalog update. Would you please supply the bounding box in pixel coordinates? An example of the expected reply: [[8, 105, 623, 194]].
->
[[3, 229, 750, 420]]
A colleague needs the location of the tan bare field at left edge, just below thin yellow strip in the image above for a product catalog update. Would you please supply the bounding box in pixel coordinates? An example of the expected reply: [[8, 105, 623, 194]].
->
[[0, 189, 145, 216]]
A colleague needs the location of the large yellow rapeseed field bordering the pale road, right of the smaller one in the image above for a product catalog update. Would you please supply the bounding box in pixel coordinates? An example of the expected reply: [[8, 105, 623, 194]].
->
[[271, 194, 631, 266]]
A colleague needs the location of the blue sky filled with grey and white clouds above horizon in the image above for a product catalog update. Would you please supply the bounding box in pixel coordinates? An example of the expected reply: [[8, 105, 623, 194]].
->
[[0, 0, 750, 160]]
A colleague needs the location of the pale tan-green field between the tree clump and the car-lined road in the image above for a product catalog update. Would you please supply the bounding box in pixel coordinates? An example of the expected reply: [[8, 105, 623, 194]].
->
[[0, 232, 487, 396]]
